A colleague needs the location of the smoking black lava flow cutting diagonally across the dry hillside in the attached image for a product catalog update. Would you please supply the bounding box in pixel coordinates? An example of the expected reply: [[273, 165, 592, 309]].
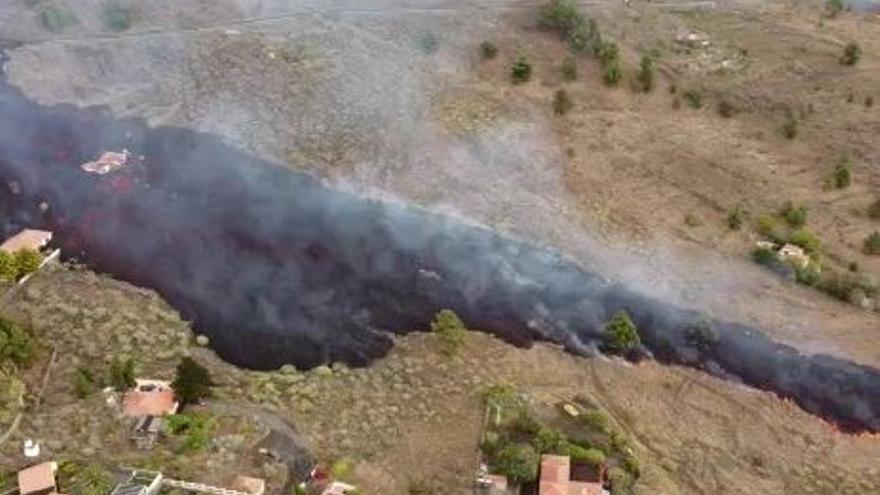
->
[[0, 68, 880, 431]]
